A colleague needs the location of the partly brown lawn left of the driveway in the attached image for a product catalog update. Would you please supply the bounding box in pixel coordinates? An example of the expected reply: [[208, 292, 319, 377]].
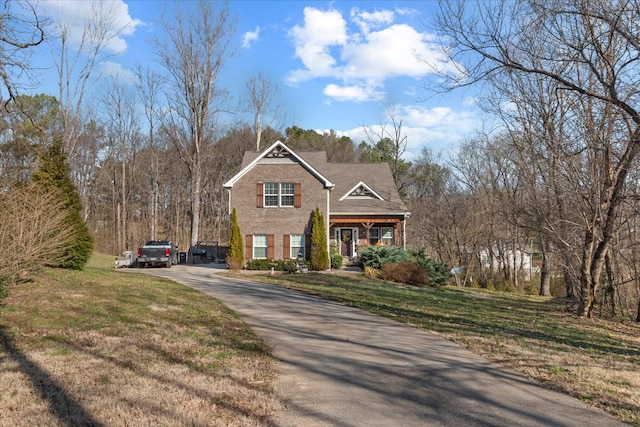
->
[[0, 258, 279, 427]]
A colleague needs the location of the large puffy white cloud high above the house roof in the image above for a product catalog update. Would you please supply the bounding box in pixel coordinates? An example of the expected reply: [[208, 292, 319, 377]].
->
[[287, 7, 458, 101]]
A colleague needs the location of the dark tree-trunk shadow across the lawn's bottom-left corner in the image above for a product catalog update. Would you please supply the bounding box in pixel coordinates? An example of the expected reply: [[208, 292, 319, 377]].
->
[[0, 326, 103, 426]]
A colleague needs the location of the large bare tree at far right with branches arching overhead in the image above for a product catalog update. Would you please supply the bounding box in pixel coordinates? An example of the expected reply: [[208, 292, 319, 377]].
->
[[439, 0, 640, 317]]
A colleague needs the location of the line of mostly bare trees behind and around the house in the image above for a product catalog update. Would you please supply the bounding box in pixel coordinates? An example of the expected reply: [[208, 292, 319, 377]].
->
[[0, 0, 640, 320]]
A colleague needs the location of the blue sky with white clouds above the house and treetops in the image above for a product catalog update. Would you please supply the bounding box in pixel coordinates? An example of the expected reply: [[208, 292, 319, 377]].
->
[[28, 0, 480, 159]]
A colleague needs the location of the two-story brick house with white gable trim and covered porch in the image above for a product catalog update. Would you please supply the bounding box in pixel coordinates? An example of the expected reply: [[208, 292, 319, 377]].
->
[[224, 141, 409, 266]]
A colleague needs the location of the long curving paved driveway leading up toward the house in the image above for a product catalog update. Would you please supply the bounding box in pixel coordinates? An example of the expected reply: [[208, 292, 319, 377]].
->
[[139, 265, 626, 427]]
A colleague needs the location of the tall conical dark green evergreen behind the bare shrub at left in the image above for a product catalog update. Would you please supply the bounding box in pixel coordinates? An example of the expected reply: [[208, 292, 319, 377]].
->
[[32, 136, 93, 270]]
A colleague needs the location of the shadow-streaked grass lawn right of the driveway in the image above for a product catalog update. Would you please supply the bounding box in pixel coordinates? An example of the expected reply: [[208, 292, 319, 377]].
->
[[230, 273, 640, 425]]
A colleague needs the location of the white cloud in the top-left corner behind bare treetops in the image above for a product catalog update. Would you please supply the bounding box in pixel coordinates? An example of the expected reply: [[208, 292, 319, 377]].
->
[[38, 0, 143, 53]]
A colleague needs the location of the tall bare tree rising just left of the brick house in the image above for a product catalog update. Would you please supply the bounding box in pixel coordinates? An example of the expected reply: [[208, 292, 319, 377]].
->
[[156, 1, 233, 246]]
